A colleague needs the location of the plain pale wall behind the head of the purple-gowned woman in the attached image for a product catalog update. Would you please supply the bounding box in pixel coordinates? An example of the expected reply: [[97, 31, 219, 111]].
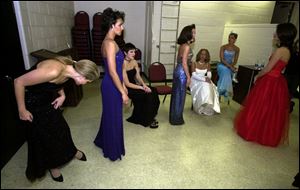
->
[[74, 1, 146, 60]]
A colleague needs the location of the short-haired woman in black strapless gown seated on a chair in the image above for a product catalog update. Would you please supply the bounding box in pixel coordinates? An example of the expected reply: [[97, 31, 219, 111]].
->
[[123, 43, 160, 128]]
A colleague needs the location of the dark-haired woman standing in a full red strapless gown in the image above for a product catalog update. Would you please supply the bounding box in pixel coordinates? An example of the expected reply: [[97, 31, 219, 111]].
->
[[234, 23, 297, 147]]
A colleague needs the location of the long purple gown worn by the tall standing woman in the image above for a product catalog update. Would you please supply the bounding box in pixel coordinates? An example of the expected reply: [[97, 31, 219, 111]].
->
[[94, 50, 125, 161]]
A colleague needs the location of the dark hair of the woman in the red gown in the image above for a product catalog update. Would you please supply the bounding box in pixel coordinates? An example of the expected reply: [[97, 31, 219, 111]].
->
[[276, 23, 297, 52]]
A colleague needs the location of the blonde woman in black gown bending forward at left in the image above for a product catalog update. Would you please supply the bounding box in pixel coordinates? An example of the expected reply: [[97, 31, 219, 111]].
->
[[15, 57, 99, 182]]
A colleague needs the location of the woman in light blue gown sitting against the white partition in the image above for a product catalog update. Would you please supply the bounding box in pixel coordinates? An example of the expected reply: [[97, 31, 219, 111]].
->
[[217, 33, 240, 102]]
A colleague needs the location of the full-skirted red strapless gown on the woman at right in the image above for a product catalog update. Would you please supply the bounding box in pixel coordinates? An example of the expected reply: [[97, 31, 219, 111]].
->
[[234, 60, 289, 147]]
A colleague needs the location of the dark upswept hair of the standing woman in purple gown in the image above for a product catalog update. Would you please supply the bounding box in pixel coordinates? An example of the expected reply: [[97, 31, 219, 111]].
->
[[101, 7, 125, 33]]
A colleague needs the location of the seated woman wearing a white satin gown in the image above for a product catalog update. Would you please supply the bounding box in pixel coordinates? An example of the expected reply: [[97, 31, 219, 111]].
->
[[190, 49, 220, 115]]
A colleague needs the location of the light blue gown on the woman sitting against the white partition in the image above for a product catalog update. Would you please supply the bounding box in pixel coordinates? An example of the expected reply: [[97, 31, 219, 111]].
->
[[217, 50, 235, 98]]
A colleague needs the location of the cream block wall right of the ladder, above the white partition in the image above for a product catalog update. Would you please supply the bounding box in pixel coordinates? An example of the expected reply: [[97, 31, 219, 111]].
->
[[178, 1, 275, 60]]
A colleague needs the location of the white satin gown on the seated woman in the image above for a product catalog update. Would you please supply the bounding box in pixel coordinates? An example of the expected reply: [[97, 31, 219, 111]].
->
[[190, 68, 221, 115]]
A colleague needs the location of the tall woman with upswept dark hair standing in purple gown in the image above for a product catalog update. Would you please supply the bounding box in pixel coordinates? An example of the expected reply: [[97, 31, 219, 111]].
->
[[94, 8, 128, 161]]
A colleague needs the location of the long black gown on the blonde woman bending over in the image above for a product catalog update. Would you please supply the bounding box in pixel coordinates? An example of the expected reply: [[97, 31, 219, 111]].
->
[[25, 66, 77, 181]]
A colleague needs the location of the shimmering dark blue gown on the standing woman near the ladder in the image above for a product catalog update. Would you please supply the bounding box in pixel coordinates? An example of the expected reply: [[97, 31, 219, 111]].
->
[[169, 58, 187, 125]]
